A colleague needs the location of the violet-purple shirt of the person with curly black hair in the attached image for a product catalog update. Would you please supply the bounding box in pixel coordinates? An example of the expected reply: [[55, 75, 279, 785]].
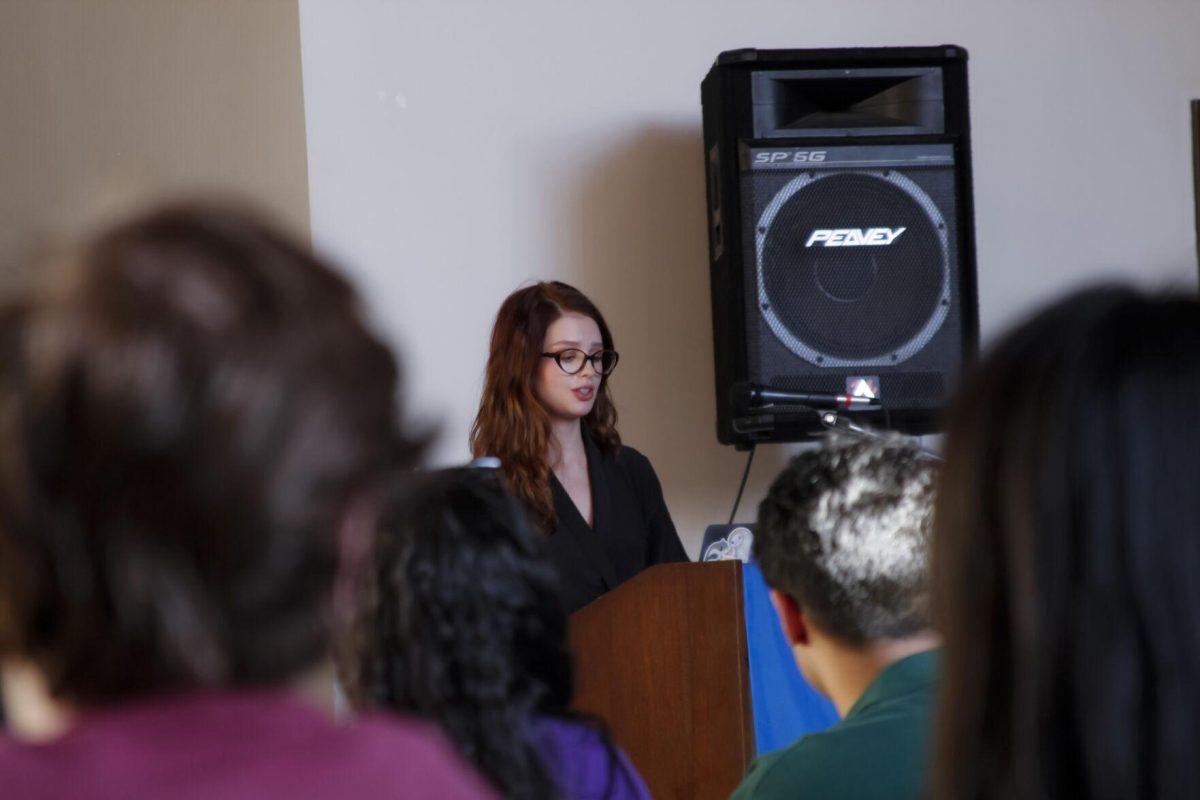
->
[[532, 717, 650, 800]]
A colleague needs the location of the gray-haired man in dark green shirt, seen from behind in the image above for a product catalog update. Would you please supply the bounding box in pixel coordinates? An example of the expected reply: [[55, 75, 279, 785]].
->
[[733, 437, 937, 800]]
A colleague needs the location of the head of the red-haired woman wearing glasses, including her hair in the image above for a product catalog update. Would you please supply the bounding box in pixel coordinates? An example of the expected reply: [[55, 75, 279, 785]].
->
[[470, 281, 620, 530]]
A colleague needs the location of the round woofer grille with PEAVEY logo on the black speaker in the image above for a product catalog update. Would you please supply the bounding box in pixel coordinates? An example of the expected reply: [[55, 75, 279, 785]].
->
[[755, 169, 952, 367]]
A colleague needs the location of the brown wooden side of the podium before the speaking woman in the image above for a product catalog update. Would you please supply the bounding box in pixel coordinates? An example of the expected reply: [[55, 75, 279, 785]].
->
[[570, 561, 755, 800]]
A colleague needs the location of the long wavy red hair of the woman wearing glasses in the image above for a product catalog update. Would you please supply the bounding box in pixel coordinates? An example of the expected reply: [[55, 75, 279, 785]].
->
[[470, 281, 620, 534]]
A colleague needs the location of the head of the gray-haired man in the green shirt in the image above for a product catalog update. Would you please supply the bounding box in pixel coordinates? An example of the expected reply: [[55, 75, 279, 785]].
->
[[752, 437, 936, 716]]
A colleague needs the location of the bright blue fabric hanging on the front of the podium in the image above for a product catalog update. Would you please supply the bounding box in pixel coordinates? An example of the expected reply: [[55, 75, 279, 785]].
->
[[742, 564, 838, 756]]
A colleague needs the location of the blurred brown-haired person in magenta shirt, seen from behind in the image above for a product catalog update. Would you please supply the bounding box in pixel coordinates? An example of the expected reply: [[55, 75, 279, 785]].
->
[[0, 206, 490, 800]]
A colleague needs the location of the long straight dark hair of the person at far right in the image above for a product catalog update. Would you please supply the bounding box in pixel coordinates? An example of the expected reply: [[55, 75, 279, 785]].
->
[[934, 288, 1200, 800]]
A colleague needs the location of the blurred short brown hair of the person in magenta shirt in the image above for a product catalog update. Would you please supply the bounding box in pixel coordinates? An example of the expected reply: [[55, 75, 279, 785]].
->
[[0, 199, 416, 719]]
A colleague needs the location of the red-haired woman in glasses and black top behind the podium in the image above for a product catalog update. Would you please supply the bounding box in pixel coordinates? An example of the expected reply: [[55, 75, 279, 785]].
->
[[470, 281, 688, 612]]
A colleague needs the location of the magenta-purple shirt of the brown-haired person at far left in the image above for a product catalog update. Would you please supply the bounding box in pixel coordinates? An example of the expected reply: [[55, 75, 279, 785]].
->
[[0, 692, 493, 800]]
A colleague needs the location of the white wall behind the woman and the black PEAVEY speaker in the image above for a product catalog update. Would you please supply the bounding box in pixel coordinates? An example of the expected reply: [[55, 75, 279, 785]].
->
[[300, 0, 1200, 554]]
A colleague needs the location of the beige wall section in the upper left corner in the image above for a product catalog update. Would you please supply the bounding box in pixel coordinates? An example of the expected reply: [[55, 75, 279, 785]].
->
[[0, 0, 308, 290]]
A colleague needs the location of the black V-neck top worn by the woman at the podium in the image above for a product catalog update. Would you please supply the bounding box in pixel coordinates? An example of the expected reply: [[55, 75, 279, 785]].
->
[[545, 433, 688, 613]]
